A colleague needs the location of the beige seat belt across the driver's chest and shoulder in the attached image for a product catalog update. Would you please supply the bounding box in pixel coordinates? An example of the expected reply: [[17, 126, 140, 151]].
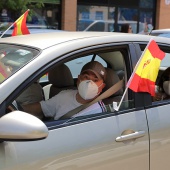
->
[[60, 79, 124, 119]]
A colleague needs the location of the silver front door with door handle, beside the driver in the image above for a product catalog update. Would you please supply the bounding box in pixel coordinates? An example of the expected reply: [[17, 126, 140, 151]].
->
[[0, 43, 149, 170]]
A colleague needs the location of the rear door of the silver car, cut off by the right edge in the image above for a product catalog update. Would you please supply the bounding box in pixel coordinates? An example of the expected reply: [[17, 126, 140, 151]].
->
[[146, 44, 170, 170]]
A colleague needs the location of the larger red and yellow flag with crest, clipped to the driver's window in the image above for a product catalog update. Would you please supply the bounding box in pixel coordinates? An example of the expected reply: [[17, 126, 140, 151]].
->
[[127, 39, 165, 96]]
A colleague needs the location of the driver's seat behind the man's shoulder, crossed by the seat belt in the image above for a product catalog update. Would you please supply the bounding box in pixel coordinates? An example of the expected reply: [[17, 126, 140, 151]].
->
[[103, 68, 123, 105]]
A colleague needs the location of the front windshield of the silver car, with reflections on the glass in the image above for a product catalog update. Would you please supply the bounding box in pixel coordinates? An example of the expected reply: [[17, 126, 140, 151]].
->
[[0, 44, 38, 83]]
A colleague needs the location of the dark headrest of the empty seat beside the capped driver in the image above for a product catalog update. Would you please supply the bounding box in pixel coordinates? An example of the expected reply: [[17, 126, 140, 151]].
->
[[48, 64, 74, 88]]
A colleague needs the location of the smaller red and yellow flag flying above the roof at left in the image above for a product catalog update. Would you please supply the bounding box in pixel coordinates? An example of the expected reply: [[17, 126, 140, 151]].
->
[[12, 10, 30, 36]]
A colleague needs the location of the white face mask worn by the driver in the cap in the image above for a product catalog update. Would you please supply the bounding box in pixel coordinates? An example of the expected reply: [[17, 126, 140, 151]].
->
[[78, 80, 103, 100]]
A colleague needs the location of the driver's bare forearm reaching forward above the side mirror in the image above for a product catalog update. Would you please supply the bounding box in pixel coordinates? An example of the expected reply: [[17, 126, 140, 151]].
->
[[22, 103, 44, 119]]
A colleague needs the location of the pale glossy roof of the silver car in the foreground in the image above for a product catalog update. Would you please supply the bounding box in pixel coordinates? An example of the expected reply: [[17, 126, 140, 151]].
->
[[0, 31, 170, 49]]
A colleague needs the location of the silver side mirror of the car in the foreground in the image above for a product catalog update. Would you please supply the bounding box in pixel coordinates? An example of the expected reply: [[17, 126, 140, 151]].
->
[[0, 111, 48, 141]]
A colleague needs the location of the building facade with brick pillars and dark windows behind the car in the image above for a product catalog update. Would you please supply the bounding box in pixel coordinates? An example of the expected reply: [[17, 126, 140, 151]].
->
[[0, 0, 170, 33]]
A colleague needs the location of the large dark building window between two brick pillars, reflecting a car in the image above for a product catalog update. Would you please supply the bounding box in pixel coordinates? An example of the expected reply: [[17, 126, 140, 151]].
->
[[77, 0, 156, 34]]
